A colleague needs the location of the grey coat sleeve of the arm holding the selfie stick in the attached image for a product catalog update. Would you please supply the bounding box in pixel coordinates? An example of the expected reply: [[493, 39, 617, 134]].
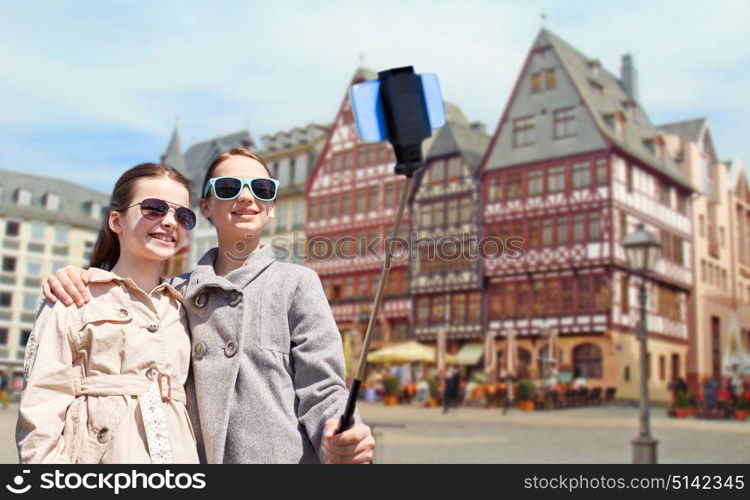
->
[[289, 268, 361, 460]]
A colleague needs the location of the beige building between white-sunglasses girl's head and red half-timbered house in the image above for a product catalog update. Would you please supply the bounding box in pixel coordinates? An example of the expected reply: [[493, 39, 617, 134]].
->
[[260, 123, 328, 264]]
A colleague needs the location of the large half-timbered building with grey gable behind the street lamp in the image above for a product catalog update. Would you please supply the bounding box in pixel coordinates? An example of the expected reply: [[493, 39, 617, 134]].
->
[[481, 29, 692, 399]]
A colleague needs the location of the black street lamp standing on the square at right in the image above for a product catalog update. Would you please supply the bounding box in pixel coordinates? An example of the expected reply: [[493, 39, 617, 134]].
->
[[622, 224, 661, 464]]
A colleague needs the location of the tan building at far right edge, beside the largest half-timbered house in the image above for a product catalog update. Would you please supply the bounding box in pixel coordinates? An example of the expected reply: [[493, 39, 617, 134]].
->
[[659, 118, 750, 387]]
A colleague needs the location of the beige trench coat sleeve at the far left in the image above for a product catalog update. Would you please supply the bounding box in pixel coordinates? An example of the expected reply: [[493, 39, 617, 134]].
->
[[16, 302, 77, 464]]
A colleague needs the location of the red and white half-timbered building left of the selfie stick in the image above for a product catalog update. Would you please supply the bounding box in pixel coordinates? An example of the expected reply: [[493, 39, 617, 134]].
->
[[305, 68, 411, 348]]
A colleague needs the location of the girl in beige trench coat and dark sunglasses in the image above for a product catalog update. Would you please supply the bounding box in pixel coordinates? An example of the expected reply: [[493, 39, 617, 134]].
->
[[16, 163, 198, 463]]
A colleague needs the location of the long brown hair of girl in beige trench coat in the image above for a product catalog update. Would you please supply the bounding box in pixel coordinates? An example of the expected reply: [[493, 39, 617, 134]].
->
[[89, 163, 190, 271]]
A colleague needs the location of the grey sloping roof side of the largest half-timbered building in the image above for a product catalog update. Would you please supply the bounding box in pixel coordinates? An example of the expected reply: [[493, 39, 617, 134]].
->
[[532, 28, 692, 189]]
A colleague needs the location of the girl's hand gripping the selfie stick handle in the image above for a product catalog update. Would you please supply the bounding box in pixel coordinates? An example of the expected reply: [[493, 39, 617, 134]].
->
[[321, 418, 375, 464]]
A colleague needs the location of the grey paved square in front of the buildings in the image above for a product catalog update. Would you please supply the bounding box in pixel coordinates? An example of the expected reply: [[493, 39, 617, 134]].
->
[[0, 403, 750, 464]]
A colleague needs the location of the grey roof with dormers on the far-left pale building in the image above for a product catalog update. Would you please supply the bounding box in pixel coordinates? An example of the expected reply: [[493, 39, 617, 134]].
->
[[0, 169, 109, 230]]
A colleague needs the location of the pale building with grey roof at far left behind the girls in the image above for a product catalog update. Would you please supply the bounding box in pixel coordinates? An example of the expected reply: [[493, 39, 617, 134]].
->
[[0, 170, 109, 390]]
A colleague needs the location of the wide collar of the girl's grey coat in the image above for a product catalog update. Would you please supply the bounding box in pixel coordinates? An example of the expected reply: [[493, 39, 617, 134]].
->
[[185, 245, 276, 300]]
